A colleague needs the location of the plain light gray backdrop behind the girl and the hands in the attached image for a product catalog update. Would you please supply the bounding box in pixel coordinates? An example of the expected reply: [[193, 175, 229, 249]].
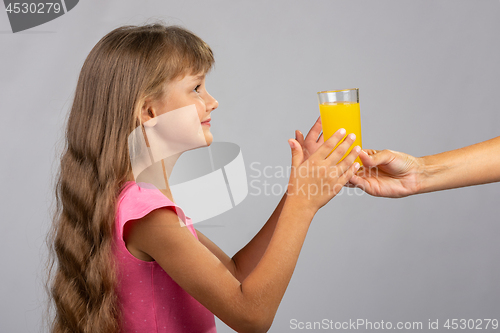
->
[[0, 0, 500, 332]]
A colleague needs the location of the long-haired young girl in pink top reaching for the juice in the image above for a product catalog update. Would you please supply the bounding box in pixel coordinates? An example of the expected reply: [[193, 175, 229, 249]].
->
[[50, 24, 359, 333]]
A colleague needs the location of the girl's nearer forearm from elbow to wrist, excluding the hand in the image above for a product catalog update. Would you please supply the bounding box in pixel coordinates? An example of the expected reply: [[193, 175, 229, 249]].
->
[[241, 197, 315, 326]]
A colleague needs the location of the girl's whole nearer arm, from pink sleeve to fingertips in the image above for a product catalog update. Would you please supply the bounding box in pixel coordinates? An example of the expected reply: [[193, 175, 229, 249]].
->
[[125, 132, 359, 332]]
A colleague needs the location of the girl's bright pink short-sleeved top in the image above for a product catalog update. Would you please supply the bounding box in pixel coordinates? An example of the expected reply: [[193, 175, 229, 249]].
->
[[114, 181, 216, 333]]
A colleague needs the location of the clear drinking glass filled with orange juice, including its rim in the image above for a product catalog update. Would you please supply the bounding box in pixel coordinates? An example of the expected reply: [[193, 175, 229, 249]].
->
[[318, 88, 363, 165]]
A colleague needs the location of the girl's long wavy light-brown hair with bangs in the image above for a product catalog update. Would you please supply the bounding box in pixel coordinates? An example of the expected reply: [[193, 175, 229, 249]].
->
[[47, 24, 214, 333]]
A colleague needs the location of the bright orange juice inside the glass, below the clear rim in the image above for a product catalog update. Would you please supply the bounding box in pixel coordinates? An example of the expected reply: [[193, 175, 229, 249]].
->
[[319, 102, 363, 165]]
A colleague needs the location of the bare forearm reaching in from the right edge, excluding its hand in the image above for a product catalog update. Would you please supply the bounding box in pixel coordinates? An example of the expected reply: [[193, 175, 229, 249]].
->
[[418, 137, 500, 193]]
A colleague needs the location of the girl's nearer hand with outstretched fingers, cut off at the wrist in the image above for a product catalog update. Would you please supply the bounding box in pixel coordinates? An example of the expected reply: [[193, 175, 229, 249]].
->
[[287, 128, 361, 213]]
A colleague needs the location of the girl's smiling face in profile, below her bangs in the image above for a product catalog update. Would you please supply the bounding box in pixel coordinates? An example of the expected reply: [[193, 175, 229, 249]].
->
[[151, 74, 219, 145]]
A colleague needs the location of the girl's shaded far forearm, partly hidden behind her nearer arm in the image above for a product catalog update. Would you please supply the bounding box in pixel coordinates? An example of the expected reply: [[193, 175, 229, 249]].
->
[[232, 192, 287, 281]]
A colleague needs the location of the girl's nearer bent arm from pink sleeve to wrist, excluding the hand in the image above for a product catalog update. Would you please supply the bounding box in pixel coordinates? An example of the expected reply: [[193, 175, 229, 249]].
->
[[131, 201, 315, 332]]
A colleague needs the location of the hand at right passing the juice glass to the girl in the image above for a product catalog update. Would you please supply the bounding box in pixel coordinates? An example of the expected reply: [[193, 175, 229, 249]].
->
[[347, 149, 422, 198]]
